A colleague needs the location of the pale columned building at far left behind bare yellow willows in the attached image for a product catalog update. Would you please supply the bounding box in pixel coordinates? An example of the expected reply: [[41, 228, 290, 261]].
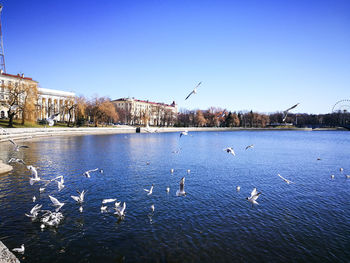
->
[[0, 71, 75, 121]]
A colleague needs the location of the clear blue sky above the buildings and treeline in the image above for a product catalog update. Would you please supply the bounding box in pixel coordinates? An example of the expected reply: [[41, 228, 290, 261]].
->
[[2, 0, 350, 113]]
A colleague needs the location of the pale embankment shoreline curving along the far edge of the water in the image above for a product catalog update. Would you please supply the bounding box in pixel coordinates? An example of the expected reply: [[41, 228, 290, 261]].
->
[[0, 126, 346, 143]]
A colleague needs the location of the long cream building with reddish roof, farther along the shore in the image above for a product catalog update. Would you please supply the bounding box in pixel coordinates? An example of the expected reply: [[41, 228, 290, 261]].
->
[[112, 98, 177, 126]]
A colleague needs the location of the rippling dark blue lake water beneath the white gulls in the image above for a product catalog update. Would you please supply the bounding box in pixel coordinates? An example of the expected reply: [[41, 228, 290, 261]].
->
[[0, 131, 350, 263]]
